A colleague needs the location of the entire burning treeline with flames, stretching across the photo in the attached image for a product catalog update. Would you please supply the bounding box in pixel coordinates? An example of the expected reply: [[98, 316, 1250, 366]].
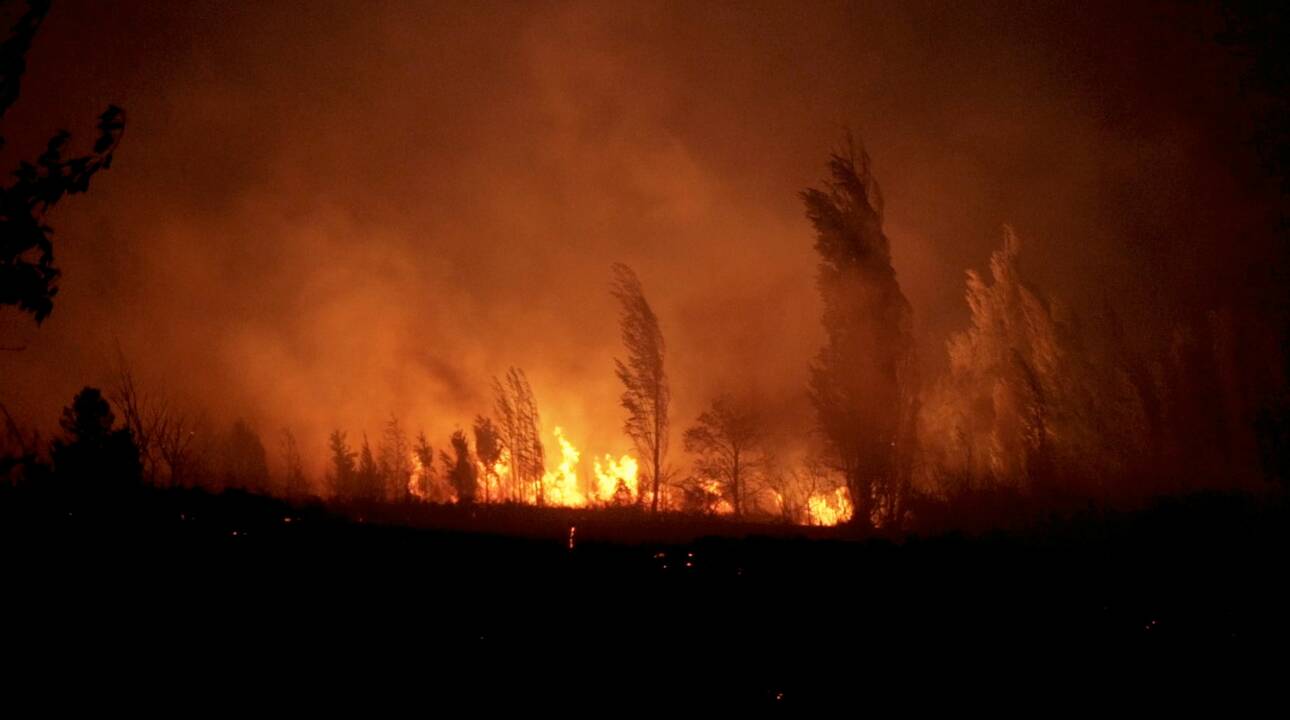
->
[[3, 136, 1287, 541]]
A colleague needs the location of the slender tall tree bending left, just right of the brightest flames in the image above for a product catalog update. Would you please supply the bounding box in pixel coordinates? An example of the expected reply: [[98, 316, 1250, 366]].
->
[[609, 263, 671, 512]]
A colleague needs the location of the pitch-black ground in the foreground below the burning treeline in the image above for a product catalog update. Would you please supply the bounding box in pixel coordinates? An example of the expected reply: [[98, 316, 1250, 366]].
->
[[0, 488, 1290, 716]]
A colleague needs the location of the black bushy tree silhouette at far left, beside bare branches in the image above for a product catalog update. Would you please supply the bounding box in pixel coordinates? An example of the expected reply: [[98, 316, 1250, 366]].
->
[[50, 387, 143, 497]]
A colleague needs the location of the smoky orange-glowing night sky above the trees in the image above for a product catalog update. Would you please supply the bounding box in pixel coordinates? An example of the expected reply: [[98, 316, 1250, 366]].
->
[[0, 0, 1275, 472]]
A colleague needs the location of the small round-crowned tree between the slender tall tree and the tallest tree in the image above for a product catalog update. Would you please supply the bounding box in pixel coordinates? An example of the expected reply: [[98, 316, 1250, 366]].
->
[[684, 394, 761, 516]]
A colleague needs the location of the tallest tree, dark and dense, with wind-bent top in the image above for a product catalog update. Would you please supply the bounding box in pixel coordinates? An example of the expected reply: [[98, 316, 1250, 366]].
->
[[801, 137, 917, 525]]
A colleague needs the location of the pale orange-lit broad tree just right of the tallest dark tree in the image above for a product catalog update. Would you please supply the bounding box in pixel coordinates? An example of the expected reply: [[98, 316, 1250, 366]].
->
[[922, 227, 1150, 495]]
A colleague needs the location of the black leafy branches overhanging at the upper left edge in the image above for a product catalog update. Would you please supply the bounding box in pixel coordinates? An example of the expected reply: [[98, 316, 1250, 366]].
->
[[0, 0, 125, 324]]
